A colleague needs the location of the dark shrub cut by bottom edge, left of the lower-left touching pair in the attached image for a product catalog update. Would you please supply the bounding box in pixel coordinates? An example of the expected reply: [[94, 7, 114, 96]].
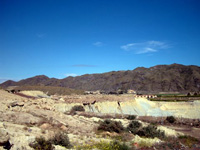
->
[[29, 137, 54, 150]]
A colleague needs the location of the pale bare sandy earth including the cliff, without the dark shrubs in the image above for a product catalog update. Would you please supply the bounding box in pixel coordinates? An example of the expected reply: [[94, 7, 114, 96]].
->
[[0, 90, 200, 150]]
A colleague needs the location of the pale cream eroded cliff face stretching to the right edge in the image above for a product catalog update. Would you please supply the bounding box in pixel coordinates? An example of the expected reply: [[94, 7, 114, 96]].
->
[[55, 98, 200, 119]]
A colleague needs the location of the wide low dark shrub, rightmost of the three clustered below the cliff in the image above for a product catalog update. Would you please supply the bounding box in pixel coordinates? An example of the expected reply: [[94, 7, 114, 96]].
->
[[136, 124, 165, 138]]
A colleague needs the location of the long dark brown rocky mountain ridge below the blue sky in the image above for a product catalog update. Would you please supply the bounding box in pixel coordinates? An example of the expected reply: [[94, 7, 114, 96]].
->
[[0, 64, 200, 92]]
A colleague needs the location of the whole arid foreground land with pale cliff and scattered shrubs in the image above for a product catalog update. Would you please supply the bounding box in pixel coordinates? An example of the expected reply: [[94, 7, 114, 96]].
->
[[0, 90, 200, 150]]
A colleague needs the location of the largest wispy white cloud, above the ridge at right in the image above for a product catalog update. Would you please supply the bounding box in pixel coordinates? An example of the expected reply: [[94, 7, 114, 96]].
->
[[121, 41, 169, 54]]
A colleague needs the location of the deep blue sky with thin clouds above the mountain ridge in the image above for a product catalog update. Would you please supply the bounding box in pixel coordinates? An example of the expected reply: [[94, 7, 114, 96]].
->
[[0, 0, 200, 82]]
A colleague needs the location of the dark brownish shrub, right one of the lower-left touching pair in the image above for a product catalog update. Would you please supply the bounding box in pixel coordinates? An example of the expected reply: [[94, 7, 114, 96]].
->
[[50, 133, 71, 148]]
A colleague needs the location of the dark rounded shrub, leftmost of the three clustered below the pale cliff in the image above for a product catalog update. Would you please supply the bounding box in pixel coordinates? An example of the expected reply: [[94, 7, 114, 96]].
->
[[98, 119, 124, 133]]
